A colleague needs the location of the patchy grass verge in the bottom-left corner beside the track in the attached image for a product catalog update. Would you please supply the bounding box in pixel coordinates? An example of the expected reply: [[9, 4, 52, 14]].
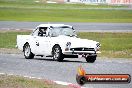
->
[[0, 75, 66, 88]]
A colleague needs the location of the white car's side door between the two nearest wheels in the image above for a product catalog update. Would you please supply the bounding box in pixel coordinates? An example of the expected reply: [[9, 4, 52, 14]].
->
[[33, 27, 51, 56]]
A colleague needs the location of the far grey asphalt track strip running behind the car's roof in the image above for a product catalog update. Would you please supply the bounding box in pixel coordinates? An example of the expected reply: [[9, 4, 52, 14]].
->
[[0, 21, 132, 32]]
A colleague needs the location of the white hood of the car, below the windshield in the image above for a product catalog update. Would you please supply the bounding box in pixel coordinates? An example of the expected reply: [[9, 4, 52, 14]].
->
[[59, 36, 98, 48]]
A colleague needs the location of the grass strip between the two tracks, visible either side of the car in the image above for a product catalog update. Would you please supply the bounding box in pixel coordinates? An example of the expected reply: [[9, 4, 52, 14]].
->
[[0, 32, 132, 58]]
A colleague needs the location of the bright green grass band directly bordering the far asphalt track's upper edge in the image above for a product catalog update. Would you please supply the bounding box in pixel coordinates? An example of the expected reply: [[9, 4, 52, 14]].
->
[[0, 8, 132, 22]]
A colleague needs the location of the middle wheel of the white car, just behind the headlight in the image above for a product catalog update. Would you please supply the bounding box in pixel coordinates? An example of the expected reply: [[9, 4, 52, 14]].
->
[[52, 45, 64, 62]]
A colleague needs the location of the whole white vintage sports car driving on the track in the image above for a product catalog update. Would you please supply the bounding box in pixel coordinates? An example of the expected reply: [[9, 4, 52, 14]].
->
[[17, 24, 100, 63]]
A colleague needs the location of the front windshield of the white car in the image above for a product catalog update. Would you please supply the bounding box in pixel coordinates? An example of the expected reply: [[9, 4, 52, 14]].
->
[[51, 27, 76, 37]]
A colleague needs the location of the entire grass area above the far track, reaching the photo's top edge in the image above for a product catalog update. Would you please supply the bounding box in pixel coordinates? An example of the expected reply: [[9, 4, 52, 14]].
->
[[0, 0, 132, 23]]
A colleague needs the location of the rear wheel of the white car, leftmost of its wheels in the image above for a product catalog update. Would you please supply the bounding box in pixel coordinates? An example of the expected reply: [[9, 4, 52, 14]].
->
[[23, 43, 34, 59]]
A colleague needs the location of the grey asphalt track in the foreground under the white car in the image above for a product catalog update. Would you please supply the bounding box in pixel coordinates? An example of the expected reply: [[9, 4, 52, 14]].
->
[[0, 54, 132, 88]]
